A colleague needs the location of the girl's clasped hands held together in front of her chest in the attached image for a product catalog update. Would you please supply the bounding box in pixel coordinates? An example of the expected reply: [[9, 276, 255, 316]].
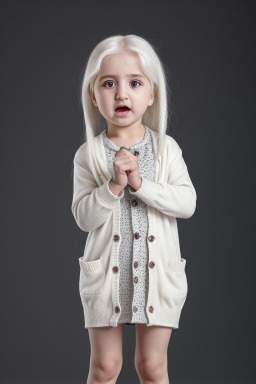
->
[[113, 148, 142, 191]]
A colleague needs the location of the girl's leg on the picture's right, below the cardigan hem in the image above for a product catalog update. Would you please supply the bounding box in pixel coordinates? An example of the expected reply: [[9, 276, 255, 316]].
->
[[134, 324, 172, 384]]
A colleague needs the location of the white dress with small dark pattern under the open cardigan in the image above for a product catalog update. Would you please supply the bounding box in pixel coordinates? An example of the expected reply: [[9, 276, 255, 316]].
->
[[103, 125, 155, 324]]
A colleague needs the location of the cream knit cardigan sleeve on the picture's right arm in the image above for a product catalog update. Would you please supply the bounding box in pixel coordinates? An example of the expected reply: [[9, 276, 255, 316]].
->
[[129, 139, 197, 219]]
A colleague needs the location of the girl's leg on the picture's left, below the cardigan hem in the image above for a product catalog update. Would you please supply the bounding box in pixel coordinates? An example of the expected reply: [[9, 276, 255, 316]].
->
[[87, 324, 124, 384]]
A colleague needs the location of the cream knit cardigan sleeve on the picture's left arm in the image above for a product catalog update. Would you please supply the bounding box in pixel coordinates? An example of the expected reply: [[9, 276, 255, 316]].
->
[[71, 156, 124, 232]]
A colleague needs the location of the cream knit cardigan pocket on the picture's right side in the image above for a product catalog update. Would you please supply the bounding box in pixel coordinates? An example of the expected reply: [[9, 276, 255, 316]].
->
[[163, 258, 188, 309]]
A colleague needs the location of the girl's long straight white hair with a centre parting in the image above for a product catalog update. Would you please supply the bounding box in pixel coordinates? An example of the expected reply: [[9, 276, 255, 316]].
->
[[81, 35, 171, 172]]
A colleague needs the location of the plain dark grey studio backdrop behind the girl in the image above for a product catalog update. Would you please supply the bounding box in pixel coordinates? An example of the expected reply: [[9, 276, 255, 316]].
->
[[0, 0, 256, 384]]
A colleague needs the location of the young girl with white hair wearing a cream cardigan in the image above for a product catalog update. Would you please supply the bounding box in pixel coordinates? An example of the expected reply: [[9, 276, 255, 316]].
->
[[71, 35, 197, 384]]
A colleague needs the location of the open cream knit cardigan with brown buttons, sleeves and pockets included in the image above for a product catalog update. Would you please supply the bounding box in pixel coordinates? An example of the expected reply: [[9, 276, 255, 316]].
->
[[71, 129, 197, 328]]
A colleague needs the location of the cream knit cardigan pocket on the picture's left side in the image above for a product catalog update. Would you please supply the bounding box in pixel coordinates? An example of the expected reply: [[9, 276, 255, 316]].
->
[[79, 256, 105, 295]]
